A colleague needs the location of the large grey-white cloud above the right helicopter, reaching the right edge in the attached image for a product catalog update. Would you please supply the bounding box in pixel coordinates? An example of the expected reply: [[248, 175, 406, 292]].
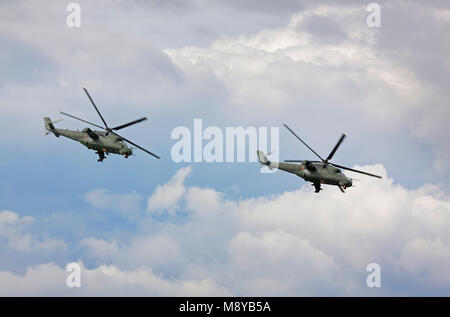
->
[[166, 4, 450, 184]]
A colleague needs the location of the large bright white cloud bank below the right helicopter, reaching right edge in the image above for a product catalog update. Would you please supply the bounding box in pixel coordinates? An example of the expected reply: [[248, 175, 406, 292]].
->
[[48, 164, 450, 296]]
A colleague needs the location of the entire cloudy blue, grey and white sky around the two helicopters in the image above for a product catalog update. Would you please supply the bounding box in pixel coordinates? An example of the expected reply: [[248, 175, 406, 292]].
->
[[0, 0, 450, 296]]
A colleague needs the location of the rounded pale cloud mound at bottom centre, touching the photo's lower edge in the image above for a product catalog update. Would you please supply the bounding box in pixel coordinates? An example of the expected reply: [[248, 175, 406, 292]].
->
[[228, 230, 345, 296]]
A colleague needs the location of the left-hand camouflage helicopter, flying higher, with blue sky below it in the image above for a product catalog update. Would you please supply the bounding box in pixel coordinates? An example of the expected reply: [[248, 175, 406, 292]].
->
[[44, 88, 159, 162]]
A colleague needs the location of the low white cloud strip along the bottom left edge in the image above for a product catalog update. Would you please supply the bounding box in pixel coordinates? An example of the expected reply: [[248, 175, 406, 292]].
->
[[0, 263, 230, 296]]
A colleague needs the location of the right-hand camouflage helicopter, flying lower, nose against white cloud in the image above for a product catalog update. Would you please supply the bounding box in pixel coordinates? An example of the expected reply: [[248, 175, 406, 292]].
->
[[257, 124, 381, 193]]
